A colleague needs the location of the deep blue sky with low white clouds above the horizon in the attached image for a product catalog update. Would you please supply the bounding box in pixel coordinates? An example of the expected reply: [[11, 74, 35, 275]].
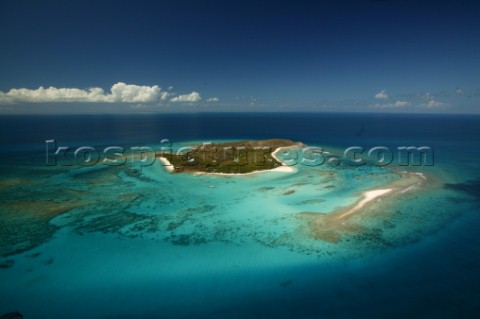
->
[[0, 0, 480, 114]]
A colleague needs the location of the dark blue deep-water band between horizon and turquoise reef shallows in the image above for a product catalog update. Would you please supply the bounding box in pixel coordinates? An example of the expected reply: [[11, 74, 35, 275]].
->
[[0, 113, 480, 152]]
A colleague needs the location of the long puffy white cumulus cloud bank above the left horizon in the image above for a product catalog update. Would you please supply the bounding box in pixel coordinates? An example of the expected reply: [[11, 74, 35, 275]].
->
[[0, 82, 184, 104]]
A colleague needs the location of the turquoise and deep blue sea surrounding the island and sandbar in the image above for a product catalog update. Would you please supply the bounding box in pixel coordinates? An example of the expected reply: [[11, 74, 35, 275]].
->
[[0, 113, 480, 319]]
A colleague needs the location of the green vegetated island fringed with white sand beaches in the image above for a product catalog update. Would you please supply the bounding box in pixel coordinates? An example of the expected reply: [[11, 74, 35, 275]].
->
[[156, 139, 303, 175]]
